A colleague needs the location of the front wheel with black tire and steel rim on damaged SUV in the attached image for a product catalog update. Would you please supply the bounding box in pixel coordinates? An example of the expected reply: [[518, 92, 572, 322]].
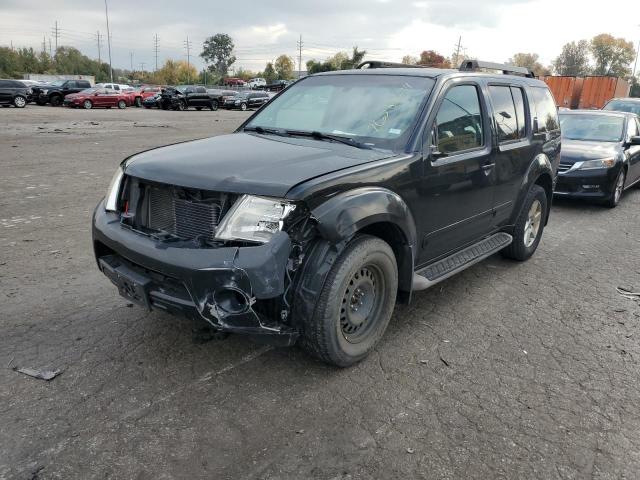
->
[[302, 235, 398, 367]]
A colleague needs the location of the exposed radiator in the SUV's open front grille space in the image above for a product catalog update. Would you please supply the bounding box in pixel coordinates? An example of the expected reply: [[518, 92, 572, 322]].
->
[[145, 186, 224, 241]]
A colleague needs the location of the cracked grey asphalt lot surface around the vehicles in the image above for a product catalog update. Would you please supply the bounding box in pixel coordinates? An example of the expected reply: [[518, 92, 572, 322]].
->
[[0, 106, 640, 480]]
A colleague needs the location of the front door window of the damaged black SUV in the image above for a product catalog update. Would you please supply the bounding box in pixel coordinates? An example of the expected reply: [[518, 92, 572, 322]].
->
[[436, 85, 484, 154]]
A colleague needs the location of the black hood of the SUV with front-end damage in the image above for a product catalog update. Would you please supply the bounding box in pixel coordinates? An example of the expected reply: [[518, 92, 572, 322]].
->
[[126, 133, 392, 197]]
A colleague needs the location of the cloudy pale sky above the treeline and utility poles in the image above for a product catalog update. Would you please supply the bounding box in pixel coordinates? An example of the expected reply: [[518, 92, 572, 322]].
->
[[0, 0, 640, 74]]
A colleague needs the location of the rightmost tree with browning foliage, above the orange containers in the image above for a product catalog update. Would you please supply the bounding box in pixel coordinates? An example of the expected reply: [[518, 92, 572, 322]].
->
[[590, 33, 636, 77]]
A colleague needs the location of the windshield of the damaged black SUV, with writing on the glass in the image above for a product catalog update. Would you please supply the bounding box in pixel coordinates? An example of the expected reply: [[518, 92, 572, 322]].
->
[[247, 74, 434, 150]]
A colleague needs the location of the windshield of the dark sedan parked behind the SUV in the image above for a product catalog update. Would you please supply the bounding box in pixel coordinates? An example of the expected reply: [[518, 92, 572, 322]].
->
[[560, 114, 624, 142]]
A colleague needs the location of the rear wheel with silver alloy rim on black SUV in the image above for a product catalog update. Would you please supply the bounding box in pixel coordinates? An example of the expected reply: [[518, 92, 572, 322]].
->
[[502, 185, 548, 262]]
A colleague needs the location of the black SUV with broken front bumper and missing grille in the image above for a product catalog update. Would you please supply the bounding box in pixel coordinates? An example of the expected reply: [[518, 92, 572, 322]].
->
[[93, 62, 560, 366]]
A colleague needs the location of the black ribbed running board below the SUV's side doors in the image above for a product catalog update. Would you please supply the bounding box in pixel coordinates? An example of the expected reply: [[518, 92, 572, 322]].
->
[[412, 232, 513, 291]]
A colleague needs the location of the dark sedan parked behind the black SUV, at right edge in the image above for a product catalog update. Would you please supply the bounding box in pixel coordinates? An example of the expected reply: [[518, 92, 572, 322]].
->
[[555, 110, 640, 207]]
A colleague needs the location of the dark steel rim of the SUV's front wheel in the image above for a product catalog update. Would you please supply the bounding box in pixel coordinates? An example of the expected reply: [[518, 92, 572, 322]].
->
[[340, 265, 384, 343]]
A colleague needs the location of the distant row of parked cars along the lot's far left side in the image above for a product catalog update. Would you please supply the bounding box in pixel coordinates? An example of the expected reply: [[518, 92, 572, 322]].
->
[[0, 80, 274, 110]]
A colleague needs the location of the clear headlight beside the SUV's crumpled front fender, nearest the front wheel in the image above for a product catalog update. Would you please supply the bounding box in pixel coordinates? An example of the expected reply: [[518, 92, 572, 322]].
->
[[216, 195, 296, 243]]
